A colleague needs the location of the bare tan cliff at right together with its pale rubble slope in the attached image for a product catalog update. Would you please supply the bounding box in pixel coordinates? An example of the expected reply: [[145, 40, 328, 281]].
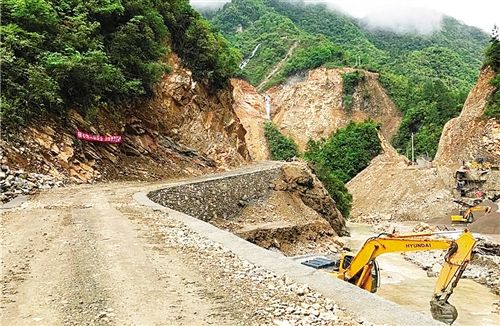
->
[[347, 69, 500, 224]]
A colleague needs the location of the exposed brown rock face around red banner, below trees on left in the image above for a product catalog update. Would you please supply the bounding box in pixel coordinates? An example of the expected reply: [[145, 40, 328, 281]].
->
[[0, 56, 250, 182]]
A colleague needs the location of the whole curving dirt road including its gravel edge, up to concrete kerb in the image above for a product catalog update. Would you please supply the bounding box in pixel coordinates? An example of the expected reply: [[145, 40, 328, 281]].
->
[[0, 163, 366, 326]]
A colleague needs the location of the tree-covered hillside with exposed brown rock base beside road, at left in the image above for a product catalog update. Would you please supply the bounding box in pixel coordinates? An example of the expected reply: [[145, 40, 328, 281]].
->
[[0, 0, 249, 182]]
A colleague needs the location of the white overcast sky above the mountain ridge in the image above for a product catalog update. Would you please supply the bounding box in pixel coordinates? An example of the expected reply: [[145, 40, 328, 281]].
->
[[190, 0, 500, 33]]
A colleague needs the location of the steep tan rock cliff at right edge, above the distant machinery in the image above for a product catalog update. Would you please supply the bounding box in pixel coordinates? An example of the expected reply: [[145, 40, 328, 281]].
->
[[435, 68, 500, 168]]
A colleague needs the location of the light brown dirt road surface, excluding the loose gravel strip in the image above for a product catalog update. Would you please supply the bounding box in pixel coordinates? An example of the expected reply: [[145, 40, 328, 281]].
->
[[0, 184, 238, 325]]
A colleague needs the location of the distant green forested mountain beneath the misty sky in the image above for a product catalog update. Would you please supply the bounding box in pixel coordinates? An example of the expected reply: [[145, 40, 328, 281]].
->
[[209, 0, 489, 157]]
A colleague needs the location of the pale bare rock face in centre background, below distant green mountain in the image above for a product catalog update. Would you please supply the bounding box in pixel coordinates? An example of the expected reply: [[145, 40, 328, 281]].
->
[[268, 68, 401, 149]]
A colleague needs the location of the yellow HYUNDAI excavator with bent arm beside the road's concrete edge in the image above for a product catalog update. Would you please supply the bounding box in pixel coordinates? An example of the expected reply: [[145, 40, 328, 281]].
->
[[334, 230, 476, 325]]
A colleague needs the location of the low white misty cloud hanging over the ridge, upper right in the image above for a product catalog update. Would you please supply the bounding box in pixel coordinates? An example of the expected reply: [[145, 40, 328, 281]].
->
[[362, 6, 443, 34]]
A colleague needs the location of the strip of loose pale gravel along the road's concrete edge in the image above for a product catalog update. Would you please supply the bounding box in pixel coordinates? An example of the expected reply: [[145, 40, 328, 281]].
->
[[154, 210, 376, 326]]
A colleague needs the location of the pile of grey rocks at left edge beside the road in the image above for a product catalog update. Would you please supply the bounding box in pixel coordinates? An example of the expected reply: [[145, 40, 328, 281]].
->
[[0, 164, 63, 203]]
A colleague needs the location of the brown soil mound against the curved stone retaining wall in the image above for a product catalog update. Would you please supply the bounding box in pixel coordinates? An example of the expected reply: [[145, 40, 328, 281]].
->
[[211, 163, 345, 255]]
